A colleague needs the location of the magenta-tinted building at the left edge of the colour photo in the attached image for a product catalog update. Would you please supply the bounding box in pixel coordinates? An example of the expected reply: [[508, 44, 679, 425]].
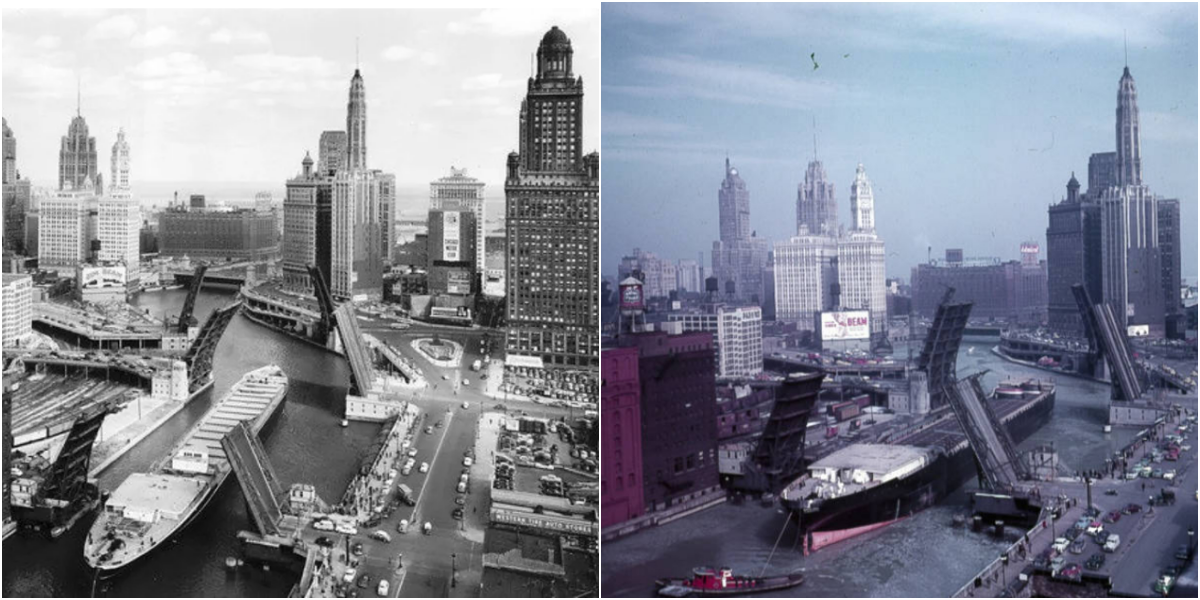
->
[[600, 347, 646, 528]]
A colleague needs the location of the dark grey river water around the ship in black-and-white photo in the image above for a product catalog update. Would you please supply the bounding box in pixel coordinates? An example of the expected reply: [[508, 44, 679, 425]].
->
[[4, 289, 379, 598]]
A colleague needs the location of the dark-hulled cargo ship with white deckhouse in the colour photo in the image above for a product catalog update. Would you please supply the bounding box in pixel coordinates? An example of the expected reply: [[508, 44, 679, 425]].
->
[[780, 379, 1055, 553]]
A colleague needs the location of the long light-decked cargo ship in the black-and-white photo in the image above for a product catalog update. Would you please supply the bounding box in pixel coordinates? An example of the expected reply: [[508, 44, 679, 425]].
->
[[83, 365, 288, 577]]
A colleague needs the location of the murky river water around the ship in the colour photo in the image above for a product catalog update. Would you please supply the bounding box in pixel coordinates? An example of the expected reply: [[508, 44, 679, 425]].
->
[[601, 342, 1138, 598]]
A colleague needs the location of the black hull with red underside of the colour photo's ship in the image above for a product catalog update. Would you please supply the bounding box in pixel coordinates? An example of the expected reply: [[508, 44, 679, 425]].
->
[[782, 390, 1056, 553]]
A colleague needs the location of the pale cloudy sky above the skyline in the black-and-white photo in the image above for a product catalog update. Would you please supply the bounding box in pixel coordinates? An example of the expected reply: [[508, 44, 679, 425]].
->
[[4, 6, 600, 196]]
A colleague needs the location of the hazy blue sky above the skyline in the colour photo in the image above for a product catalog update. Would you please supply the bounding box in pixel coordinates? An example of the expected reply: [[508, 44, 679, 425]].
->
[[601, 4, 1198, 283]]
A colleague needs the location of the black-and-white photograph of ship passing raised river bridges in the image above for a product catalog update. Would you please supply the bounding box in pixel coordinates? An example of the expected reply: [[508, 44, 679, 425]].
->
[[0, 2, 600, 598]]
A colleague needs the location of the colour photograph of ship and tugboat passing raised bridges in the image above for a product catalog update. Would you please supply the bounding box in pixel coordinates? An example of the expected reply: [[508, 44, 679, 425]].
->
[[600, 2, 1198, 598]]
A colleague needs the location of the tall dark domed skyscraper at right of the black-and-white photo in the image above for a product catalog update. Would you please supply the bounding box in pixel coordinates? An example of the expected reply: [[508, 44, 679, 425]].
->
[[504, 26, 600, 367]]
